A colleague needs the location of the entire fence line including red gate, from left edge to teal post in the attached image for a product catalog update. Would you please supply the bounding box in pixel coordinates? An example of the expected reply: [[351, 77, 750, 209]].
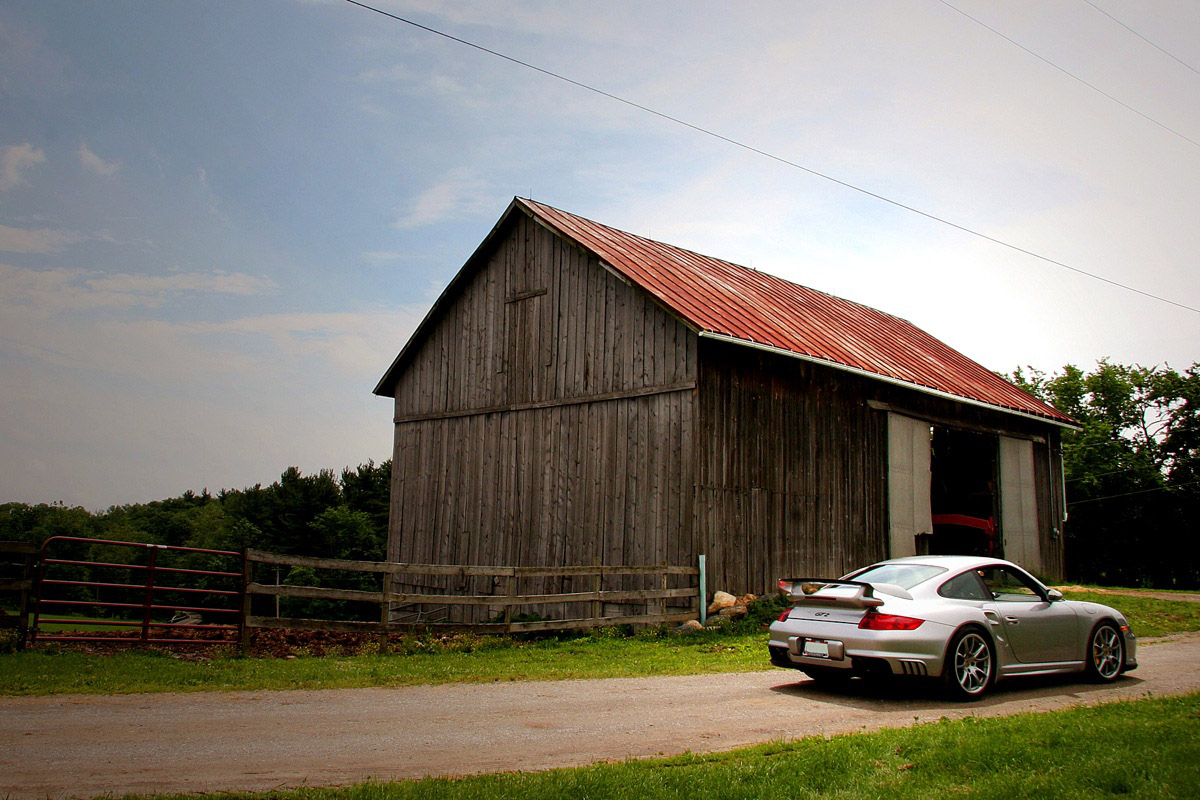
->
[[0, 537, 707, 651]]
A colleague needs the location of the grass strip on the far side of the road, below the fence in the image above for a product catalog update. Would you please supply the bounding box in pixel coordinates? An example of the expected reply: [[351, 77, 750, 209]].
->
[[0, 593, 1200, 694]]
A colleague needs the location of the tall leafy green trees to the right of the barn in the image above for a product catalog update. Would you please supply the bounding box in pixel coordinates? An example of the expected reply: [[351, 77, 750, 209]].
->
[[1006, 361, 1200, 589]]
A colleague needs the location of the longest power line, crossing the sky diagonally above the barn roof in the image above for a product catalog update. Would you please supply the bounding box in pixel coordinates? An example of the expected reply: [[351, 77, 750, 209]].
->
[[346, 0, 1200, 314]]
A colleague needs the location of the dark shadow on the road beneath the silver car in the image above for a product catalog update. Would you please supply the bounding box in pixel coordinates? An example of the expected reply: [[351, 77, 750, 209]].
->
[[770, 674, 1145, 711]]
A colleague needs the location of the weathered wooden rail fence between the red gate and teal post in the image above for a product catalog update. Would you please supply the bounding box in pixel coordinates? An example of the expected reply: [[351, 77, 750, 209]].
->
[[242, 549, 706, 650]]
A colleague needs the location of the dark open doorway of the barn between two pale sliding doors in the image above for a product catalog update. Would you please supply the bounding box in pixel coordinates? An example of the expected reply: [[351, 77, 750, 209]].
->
[[919, 426, 1002, 557]]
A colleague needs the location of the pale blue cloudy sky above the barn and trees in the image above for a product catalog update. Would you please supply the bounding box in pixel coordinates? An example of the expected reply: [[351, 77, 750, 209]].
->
[[0, 0, 1200, 510]]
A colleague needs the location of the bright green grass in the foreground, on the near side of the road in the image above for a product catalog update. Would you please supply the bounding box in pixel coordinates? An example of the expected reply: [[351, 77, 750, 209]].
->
[[119, 694, 1200, 800]]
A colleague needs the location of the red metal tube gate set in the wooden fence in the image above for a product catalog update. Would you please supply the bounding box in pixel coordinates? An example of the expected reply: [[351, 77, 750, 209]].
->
[[30, 536, 244, 644]]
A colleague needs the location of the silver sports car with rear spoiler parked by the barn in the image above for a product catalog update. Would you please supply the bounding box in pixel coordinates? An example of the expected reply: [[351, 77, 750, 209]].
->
[[768, 555, 1138, 700]]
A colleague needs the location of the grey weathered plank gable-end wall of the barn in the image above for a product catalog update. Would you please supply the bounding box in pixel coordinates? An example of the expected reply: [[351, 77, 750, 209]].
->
[[388, 209, 696, 589]]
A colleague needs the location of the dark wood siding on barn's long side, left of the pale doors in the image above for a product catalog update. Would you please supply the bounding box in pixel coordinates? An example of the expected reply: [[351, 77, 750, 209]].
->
[[696, 341, 887, 593]]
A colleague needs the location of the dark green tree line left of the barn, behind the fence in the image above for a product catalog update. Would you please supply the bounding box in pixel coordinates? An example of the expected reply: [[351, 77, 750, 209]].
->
[[0, 461, 391, 619]]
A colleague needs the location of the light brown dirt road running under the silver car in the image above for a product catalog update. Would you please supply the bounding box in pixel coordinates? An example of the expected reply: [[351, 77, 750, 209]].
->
[[0, 634, 1200, 800]]
